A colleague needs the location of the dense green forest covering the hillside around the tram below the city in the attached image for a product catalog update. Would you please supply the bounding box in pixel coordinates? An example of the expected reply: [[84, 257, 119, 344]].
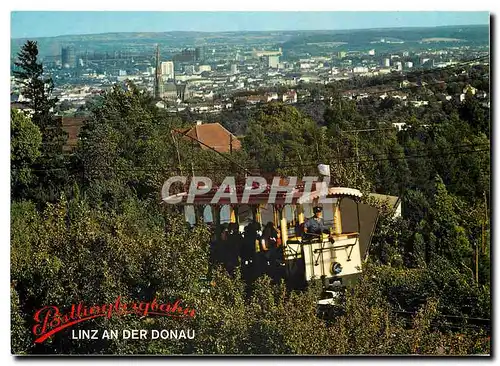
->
[[11, 42, 491, 355]]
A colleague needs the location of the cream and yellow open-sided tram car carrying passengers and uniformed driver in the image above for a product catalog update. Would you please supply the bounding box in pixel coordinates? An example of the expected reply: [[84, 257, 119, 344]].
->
[[162, 177, 377, 289]]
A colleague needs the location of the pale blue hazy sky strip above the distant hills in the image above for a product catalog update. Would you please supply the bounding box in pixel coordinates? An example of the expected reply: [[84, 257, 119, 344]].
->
[[11, 11, 489, 38]]
